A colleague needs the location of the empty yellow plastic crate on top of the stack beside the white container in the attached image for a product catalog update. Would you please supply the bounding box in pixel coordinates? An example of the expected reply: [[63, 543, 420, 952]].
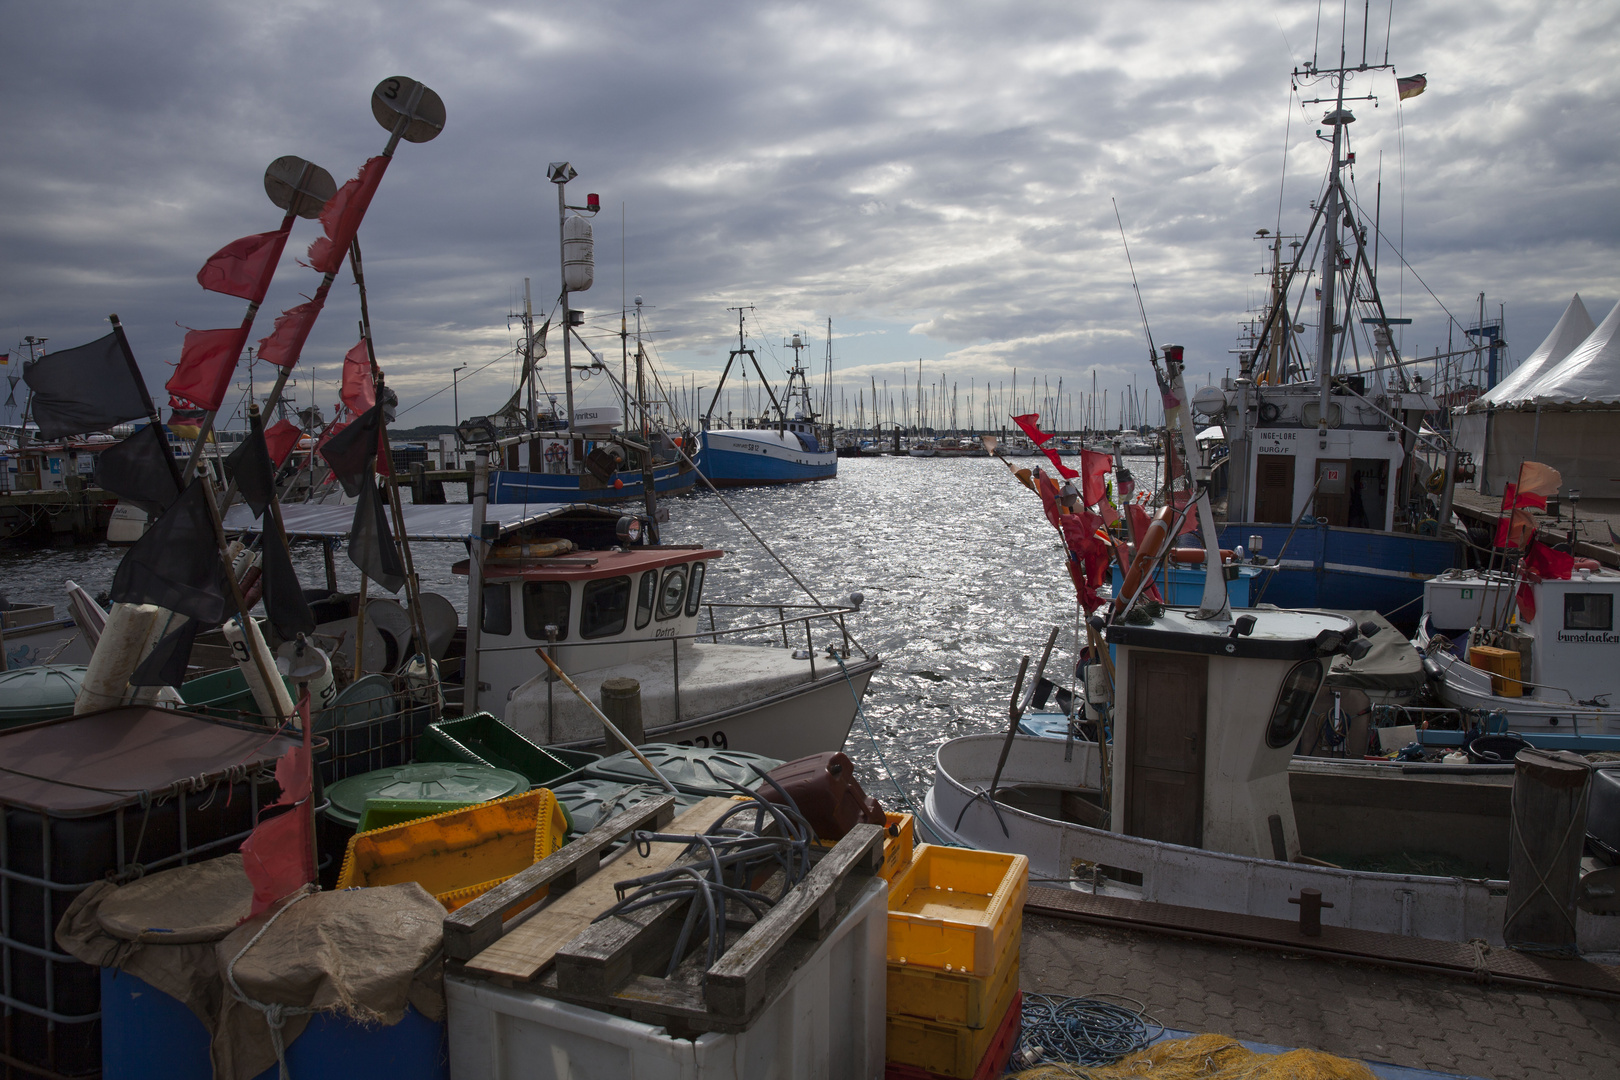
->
[[888, 844, 1029, 975]]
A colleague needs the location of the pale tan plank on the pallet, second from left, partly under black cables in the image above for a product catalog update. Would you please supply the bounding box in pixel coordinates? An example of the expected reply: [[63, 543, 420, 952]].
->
[[467, 798, 737, 983]]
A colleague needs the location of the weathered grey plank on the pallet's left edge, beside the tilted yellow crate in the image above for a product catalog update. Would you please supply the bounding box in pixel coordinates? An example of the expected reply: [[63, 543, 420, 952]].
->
[[444, 795, 676, 960]]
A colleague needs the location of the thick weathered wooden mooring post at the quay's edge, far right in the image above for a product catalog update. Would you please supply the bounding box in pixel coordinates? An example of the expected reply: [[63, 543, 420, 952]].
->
[[1502, 750, 1592, 952]]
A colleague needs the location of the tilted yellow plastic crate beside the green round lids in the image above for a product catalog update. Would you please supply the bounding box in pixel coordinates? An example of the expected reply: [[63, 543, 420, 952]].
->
[[337, 789, 569, 912]]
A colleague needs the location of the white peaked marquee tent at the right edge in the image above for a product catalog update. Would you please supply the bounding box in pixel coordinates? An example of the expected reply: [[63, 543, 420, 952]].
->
[[1452, 296, 1620, 499]]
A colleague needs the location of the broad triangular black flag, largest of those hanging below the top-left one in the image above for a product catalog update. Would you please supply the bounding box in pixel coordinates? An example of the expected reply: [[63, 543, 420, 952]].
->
[[112, 478, 230, 627]]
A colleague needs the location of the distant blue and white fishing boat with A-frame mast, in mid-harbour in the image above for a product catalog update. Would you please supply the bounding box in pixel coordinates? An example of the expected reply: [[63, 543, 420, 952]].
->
[[698, 308, 838, 487]]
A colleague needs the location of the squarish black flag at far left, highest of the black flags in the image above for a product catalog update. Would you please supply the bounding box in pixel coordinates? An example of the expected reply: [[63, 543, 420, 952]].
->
[[23, 330, 152, 439]]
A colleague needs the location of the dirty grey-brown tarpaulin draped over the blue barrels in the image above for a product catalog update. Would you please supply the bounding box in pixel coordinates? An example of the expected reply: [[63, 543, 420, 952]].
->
[[57, 855, 444, 1080]]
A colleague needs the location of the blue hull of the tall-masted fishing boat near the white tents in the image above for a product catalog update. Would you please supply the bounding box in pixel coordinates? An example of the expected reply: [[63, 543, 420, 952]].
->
[[1220, 521, 1461, 627]]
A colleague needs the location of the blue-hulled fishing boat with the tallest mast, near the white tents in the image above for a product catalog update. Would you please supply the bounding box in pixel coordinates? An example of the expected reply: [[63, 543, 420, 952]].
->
[[1194, 66, 1460, 628]]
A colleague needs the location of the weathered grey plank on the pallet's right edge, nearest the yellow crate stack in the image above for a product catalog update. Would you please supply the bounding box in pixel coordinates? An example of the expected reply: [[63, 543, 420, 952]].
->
[[703, 824, 885, 1017]]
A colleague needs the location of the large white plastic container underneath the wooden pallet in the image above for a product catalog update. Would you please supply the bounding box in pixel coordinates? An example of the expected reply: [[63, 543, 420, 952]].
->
[[444, 879, 889, 1080]]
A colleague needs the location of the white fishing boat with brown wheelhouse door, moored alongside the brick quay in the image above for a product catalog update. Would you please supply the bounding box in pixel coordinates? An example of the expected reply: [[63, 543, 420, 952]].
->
[[923, 347, 1620, 952]]
